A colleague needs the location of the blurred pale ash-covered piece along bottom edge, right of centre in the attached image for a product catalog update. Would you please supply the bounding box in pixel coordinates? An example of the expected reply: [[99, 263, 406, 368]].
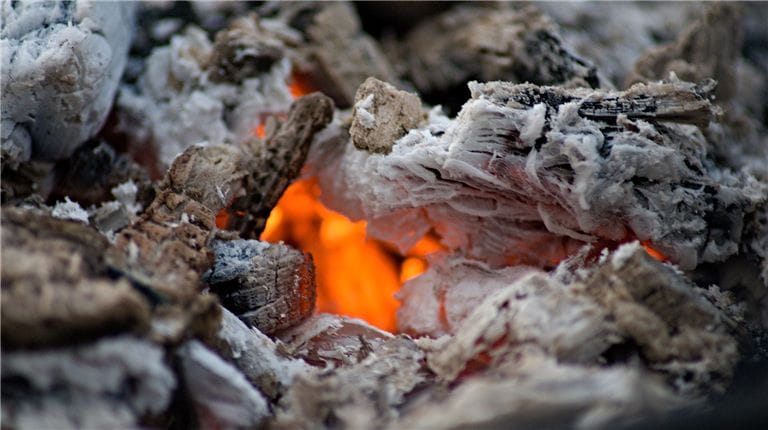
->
[[388, 351, 689, 429]]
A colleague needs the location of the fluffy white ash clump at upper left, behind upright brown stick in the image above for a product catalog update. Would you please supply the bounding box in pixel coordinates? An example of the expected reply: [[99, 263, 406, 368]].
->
[[117, 21, 292, 165]]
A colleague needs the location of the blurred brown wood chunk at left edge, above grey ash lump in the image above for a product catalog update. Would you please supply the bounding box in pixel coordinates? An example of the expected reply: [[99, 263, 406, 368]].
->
[[1, 208, 150, 348]]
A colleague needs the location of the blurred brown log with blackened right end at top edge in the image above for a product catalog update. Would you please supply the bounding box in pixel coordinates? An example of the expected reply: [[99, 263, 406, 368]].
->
[[390, 5, 610, 102]]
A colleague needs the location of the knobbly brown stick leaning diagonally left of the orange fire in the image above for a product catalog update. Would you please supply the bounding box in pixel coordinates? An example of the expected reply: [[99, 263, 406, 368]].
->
[[111, 94, 333, 303]]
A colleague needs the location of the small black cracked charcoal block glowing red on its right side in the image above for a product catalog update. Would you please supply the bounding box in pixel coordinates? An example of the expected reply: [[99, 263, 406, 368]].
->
[[204, 240, 316, 334]]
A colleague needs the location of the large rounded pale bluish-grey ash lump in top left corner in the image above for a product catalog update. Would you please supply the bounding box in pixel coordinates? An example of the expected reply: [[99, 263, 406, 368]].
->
[[0, 1, 135, 161]]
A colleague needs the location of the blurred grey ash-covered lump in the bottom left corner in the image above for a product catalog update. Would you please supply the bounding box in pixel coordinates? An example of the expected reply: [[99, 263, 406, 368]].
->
[[2, 336, 176, 429]]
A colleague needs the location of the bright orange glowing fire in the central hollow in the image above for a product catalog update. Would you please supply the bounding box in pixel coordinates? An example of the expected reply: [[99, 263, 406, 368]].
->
[[261, 179, 440, 331]]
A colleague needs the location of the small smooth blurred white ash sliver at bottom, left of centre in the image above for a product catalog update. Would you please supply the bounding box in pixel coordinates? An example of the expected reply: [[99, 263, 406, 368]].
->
[[177, 340, 269, 428]]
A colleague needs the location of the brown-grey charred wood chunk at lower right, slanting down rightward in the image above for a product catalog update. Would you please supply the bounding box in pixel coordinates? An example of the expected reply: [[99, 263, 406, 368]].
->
[[585, 243, 748, 395]]
